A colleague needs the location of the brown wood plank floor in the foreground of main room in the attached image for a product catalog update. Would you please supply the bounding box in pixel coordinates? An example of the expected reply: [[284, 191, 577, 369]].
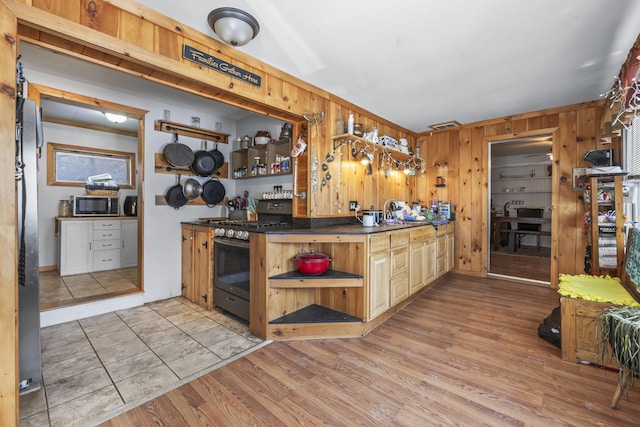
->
[[97, 275, 640, 427]]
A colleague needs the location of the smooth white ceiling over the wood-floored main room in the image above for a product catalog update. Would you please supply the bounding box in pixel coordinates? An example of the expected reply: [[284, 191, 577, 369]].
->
[[138, 0, 640, 132]]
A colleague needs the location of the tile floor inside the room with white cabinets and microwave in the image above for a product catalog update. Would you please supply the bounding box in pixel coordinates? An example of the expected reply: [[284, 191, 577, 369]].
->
[[40, 267, 138, 304]]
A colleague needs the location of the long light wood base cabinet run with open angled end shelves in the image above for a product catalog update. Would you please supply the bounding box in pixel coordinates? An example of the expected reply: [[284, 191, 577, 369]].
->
[[258, 224, 453, 340]]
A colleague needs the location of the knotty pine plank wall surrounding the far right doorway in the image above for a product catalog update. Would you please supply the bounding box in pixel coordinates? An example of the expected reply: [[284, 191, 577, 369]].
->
[[416, 101, 608, 284]]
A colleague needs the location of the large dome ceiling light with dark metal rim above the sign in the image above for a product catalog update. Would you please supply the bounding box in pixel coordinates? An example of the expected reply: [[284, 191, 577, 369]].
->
[[207, 7, 260, 47]]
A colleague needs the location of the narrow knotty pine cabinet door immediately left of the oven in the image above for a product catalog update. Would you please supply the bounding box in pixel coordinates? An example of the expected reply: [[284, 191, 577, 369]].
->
[[193, 231, 213, 310]]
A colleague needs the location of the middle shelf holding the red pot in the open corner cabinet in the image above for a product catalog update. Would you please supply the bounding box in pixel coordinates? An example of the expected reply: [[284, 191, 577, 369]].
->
[[269, 269, 364, 288]]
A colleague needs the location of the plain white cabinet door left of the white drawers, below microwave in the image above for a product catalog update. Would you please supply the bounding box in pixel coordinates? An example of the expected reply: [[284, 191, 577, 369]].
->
[[58, 221, 93, 276]]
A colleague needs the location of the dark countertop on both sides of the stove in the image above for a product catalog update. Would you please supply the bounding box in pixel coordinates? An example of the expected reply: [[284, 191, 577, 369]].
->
[[182, 221, 444, 234]]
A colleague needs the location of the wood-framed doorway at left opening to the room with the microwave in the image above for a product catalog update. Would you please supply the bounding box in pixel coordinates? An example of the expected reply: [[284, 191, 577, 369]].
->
[[29, 83, 146, 311]]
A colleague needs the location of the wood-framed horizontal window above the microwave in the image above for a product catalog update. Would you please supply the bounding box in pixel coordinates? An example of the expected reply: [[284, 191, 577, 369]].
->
[[47, 142, 136, 188]]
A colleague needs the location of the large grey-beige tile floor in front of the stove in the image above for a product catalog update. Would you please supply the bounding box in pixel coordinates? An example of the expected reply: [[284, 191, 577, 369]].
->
[[20, 297, 263, 427]]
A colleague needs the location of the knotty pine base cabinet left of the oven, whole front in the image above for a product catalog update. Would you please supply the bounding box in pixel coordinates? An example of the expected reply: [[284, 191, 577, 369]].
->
[[181, 224, 214, 310]]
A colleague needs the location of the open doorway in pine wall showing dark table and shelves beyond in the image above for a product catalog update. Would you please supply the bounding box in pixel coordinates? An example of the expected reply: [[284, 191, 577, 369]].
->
[[488, 134, 553, 284]]
